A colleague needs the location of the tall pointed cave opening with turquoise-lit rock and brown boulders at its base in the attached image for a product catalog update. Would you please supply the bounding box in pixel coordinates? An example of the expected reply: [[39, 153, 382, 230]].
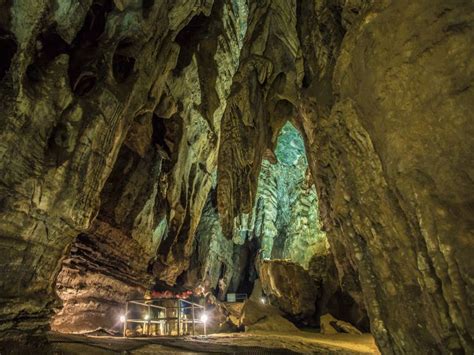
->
[[215, 121, 370, 332]]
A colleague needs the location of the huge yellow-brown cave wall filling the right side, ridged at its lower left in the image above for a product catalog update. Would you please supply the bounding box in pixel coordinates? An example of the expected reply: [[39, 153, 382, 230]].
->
[[305, 1, 473, 353]]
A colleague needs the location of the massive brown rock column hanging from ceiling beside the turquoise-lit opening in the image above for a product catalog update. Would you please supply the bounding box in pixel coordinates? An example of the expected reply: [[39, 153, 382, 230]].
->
[[217, 0, 301, 237]]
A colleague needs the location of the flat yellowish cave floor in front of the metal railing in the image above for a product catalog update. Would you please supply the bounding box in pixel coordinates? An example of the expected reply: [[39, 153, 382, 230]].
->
[[48, 331, 380, 355]]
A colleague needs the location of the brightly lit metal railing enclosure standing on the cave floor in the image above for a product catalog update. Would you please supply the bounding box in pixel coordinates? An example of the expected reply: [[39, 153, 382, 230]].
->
[[123, 298, 207, 337]]
